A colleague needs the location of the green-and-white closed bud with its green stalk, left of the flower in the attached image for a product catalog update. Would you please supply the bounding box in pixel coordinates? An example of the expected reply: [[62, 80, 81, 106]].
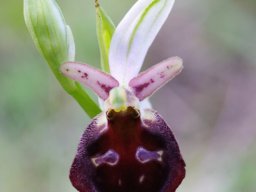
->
[[24, 0, 100, 117]]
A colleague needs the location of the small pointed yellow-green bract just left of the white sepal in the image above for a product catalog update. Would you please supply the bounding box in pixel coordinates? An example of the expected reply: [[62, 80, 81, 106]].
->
[[95, 0, 115, 73]]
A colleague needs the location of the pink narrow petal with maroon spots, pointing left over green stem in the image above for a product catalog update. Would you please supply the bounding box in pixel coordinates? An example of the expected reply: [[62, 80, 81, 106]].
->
[[61, 62, 119, 100]]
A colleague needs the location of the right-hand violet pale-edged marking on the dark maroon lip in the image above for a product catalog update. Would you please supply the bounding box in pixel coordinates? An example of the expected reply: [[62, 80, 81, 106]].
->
[[135, 147, 163, 164]]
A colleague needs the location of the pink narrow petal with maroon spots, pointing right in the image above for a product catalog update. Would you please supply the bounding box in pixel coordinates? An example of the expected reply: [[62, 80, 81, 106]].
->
[[129, 57, 183, 101]]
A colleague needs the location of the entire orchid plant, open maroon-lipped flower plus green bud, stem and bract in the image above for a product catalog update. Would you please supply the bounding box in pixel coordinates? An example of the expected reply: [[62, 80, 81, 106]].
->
[[24, 0, 185, 192]]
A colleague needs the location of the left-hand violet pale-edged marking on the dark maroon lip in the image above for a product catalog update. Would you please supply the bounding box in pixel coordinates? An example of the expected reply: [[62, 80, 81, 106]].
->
[[91, 150, 120, 167]]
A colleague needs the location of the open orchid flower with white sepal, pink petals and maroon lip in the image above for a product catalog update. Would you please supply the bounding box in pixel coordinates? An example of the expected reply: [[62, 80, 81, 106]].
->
[[61, 0, 185, 192]]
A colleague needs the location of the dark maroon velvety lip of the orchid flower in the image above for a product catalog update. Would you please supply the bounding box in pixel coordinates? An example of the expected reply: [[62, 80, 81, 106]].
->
[[70, 107, 185, 192]]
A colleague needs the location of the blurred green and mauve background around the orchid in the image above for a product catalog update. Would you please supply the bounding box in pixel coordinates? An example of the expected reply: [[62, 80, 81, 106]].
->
[[0, 0, 256, 192]]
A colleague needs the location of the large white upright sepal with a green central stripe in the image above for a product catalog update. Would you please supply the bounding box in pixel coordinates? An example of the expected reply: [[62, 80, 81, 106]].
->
[[109, 0, 174, 85]]
